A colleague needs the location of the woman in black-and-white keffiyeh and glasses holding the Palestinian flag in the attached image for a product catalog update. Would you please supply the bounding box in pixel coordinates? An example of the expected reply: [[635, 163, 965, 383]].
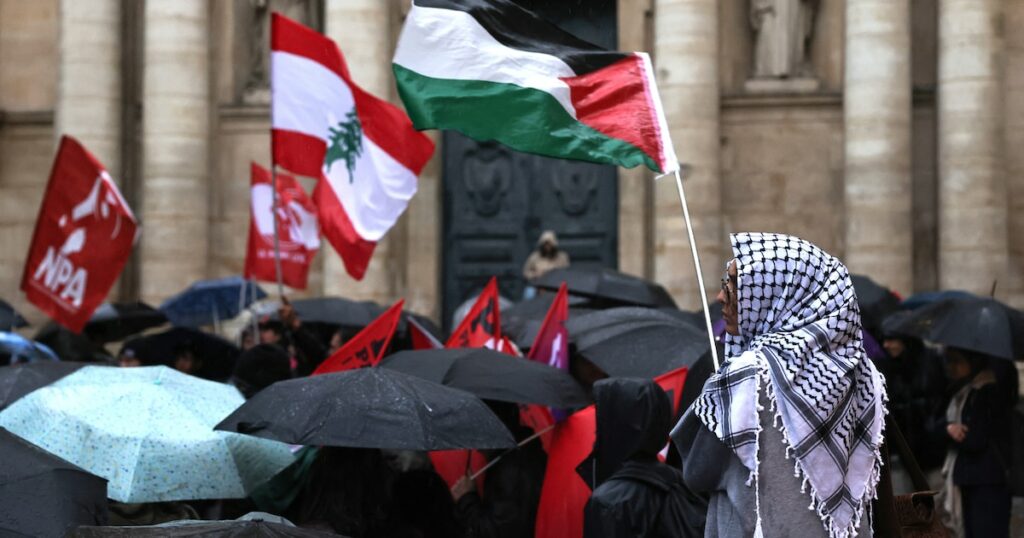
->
[[673, 234, 886, 538]]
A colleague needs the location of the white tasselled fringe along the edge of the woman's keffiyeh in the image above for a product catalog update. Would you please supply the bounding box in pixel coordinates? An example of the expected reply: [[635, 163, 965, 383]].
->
[[746, 361, 889, 538]]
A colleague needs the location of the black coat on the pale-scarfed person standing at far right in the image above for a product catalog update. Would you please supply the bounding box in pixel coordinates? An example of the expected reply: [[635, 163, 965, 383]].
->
[[953, 383, 1013, 486]]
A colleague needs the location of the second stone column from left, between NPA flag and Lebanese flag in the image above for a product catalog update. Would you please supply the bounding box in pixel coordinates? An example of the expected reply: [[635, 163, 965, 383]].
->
[[138, 0, 209, 303]]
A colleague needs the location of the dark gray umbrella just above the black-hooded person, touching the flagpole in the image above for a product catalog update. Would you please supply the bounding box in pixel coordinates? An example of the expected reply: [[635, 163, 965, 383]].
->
[[566, 307, 711, 378]]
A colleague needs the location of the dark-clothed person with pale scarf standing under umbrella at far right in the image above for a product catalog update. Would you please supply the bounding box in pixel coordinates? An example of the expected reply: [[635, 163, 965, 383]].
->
[[938, 346, 1016, 538]]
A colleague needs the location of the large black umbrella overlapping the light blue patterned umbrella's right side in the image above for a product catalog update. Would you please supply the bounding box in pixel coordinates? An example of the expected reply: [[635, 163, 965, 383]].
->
[[217, 368, 515, 450]]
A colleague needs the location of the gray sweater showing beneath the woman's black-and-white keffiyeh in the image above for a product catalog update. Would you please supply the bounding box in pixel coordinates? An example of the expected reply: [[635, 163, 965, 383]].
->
[[674, 396, 871, 538]]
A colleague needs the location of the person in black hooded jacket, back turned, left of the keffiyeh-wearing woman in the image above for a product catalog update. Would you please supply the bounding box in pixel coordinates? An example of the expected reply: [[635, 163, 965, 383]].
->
[[579, 378, 707, 538]]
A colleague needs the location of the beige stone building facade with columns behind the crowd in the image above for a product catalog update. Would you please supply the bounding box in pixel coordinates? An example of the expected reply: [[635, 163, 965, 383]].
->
[[0, 0, 1024, 325]]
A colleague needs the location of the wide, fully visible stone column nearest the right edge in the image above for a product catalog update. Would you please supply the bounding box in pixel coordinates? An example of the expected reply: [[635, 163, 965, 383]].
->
[[938, 0, 1007, 295]]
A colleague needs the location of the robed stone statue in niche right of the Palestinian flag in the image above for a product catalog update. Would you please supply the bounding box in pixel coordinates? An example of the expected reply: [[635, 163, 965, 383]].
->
[[750, 0, 818, 79]]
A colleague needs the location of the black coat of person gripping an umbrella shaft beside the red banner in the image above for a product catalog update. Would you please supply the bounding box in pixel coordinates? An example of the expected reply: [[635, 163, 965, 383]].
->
[[456, 442, 548, 538]]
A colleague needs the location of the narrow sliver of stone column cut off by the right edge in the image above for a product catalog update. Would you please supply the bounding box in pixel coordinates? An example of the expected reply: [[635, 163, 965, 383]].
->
[[1002, 0, 1024, 308]]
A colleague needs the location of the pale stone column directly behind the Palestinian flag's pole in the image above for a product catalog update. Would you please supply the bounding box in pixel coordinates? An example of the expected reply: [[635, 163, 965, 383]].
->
[[653, 0, 731, 308]]
